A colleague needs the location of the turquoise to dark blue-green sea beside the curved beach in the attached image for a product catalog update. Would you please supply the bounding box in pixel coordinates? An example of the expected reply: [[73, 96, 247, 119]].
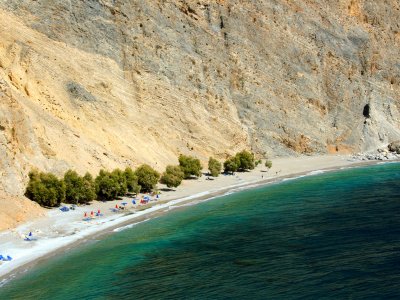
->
[[0, 163, 400, 299]]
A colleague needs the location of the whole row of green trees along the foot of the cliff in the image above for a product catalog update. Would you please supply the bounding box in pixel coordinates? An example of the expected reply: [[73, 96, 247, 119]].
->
[[25, 151, 267, 207]]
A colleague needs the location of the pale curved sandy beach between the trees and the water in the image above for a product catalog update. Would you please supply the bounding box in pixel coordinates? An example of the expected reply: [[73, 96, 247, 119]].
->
[[0, 156, 396, 286]]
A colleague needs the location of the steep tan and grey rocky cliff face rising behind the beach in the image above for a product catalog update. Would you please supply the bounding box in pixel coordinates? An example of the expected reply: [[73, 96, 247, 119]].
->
[[0, 0, 400, 194]]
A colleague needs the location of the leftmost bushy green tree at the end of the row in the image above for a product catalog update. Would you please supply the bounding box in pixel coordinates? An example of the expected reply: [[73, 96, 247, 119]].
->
[[25, 171, 65, 207]]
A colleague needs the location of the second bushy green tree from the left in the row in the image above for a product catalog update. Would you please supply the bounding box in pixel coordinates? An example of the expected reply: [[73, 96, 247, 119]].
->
[[64, 170, 96, 204]]
